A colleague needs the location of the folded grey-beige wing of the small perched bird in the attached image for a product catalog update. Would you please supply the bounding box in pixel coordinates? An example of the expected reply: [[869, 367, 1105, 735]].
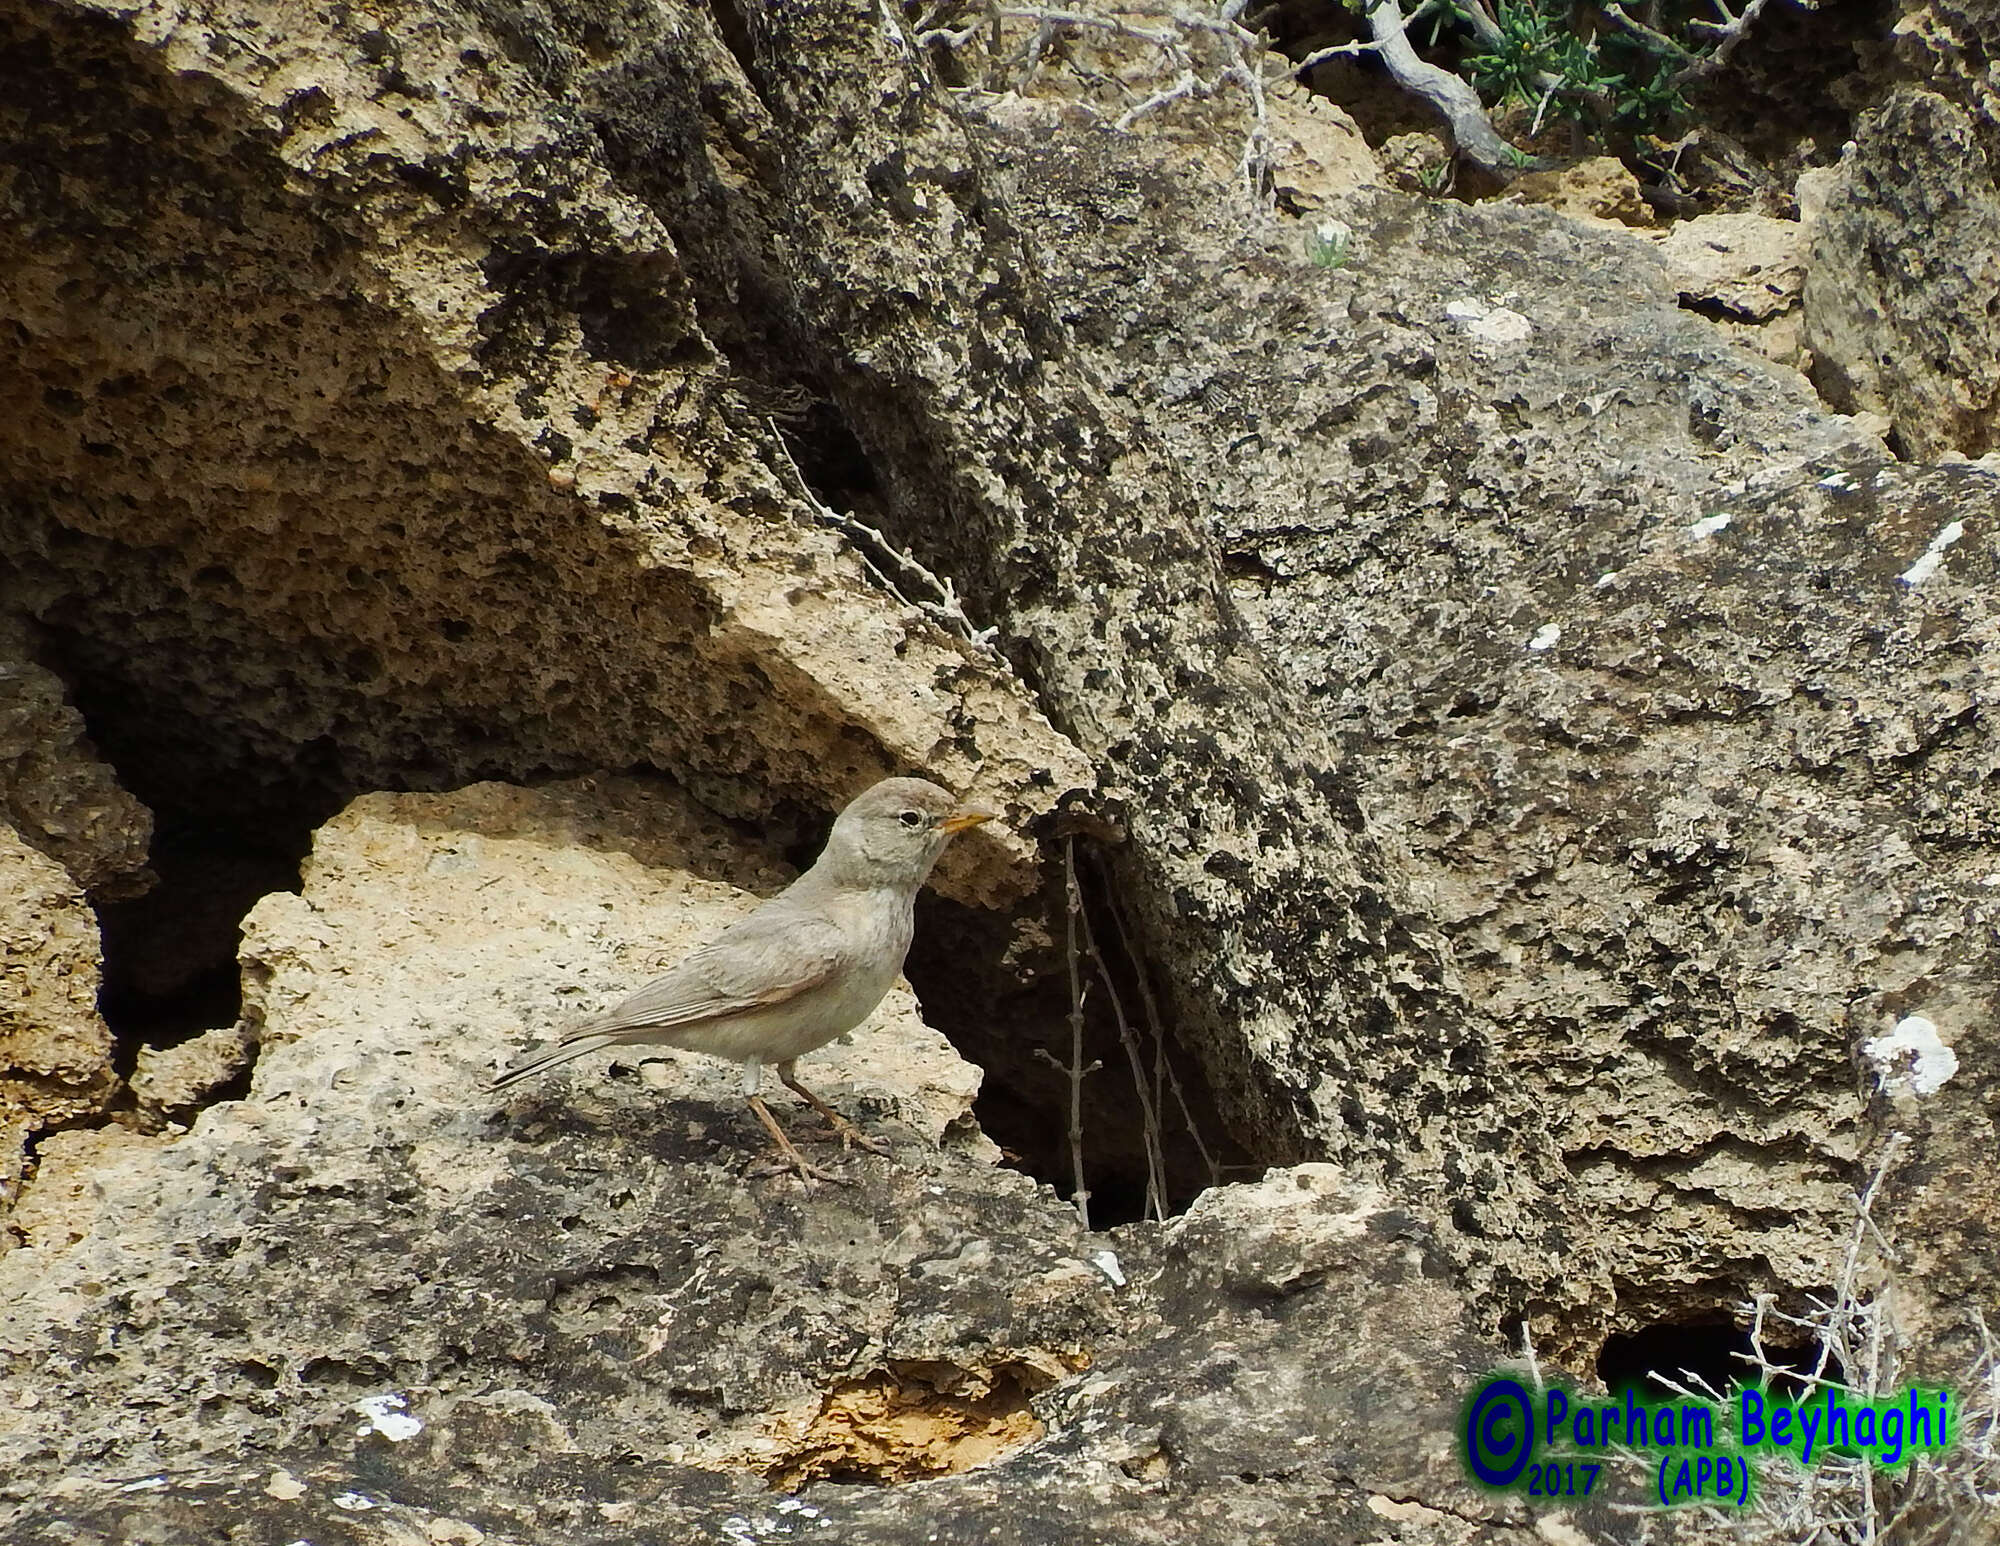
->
[[562, 898, 846, 1042]]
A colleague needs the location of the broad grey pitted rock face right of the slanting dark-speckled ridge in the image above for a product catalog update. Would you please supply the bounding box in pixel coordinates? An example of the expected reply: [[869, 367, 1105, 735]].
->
[[996, 96, 2000, 1336]]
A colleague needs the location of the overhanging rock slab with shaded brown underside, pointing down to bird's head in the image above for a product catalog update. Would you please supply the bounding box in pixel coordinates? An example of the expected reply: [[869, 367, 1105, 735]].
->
[[0, 6, 1082, 900]]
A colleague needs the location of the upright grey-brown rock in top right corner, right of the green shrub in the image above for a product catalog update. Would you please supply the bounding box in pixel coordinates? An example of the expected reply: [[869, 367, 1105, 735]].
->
[[1806, 0, 2000, 458]]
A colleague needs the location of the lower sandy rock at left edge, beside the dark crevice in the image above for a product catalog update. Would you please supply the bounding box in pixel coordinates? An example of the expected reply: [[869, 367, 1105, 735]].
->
[[0, 826, 118, 1202]]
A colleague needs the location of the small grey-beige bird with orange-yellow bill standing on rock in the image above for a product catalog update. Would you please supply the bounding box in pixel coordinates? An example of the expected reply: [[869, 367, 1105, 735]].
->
[[492, 778, 994, 1188]]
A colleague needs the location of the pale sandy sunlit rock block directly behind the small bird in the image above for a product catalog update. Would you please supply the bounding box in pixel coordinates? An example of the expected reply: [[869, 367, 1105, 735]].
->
[[244, 778, 994, 1158]]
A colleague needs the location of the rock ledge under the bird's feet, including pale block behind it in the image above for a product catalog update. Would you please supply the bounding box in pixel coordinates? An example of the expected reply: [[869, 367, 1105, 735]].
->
[[0, 780, 1530, 1546]]
